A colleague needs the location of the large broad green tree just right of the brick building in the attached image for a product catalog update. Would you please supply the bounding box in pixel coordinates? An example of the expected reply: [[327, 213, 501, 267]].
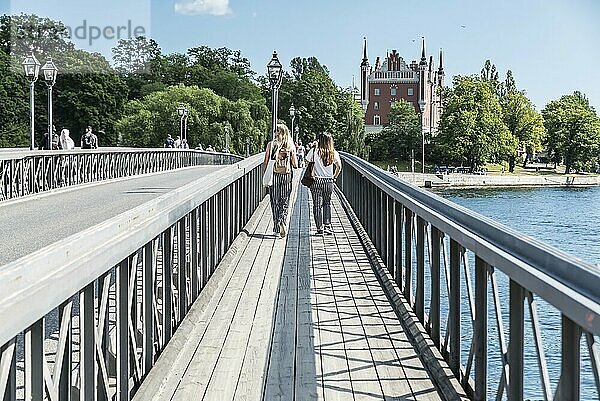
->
[[432, 76, 517, 170]]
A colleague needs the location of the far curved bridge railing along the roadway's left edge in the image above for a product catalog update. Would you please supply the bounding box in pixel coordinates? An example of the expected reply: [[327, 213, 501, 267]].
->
[[0, 148, 242, 201]]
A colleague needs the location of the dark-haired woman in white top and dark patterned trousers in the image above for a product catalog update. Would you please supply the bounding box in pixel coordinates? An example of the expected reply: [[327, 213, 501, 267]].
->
[[306, 132, 342, 235]]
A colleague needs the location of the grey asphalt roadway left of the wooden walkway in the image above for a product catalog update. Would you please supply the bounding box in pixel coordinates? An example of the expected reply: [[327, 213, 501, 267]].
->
[[0, 166, 223, 268]]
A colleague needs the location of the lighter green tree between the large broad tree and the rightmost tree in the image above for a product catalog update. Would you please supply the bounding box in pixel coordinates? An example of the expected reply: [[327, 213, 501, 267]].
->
[[500, 89, 546, 172]]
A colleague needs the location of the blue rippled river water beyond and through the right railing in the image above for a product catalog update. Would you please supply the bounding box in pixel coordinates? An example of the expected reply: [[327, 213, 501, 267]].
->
[[436, 187, 600, 400]]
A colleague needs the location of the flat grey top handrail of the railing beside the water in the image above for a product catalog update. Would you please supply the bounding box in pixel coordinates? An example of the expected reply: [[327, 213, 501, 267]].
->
[[342, 152, 600, 335]]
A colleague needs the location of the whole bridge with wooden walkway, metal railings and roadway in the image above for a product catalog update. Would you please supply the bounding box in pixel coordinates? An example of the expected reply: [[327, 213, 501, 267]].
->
[[0, 150, 600, 401]]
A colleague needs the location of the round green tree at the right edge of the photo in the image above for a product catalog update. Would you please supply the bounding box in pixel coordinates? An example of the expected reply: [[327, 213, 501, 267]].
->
[[542, 92, 600, 174]]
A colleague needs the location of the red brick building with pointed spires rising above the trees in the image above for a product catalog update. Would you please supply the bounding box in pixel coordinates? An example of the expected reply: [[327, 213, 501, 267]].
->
[[360, 38, 445, 134]]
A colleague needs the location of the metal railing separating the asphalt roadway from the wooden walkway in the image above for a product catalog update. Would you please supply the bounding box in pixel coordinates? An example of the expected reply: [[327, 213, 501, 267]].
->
[[0, 156, 265, 401]]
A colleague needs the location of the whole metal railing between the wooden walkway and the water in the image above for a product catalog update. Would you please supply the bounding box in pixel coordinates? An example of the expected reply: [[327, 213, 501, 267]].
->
[[339, 154, 600, 401]]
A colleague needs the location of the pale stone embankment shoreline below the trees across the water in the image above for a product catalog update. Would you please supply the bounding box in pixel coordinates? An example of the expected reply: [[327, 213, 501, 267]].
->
[[389, 173, 600, 188]]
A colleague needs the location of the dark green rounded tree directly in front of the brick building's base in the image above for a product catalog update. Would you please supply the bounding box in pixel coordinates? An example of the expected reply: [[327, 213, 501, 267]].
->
[[369, 100, 422, 160]]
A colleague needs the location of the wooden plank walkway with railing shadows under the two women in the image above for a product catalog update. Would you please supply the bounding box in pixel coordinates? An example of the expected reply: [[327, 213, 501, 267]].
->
[[134, 180, 442, 401]]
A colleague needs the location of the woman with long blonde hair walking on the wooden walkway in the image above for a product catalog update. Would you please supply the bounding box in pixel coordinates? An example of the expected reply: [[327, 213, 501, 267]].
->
[[264, 124, 298, 238]]
